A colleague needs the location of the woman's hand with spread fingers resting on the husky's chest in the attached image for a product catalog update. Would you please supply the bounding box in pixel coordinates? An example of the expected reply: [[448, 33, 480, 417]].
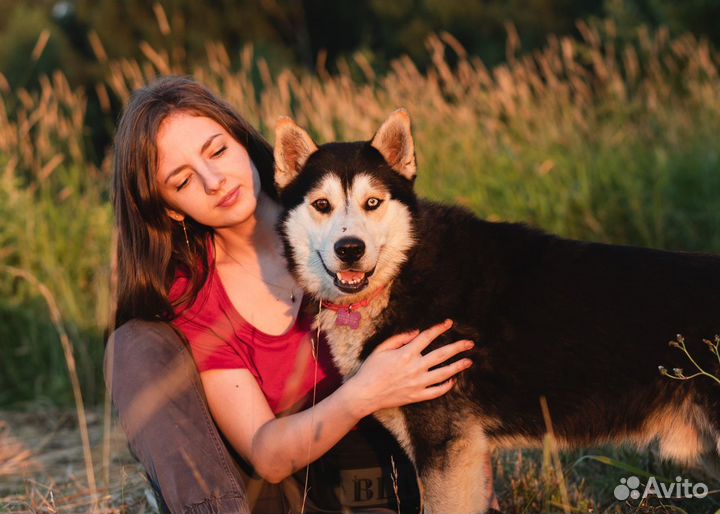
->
[[343, 320, 474, 417]]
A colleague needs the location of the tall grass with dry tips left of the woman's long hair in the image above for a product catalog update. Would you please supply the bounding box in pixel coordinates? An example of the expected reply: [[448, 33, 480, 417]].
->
[[0, 68, 112, 404]]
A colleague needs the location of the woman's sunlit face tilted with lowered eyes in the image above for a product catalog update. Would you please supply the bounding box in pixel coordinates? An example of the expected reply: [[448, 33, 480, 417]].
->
[[156, 112, 260, 228]]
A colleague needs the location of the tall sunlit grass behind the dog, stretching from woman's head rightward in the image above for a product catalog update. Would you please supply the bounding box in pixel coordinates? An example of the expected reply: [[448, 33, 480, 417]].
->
[[104, 23, 720, 249]]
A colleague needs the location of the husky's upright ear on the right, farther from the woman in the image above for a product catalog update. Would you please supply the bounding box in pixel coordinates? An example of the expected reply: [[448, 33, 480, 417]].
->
[[370, 109, 417, 181]]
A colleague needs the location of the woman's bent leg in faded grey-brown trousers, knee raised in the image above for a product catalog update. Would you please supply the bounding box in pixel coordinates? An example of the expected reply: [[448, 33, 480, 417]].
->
[[105, 321, 246, 512]]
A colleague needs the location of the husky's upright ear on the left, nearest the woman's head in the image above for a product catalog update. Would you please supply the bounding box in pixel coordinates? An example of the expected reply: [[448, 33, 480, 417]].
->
[[275, 116, 317, 189]]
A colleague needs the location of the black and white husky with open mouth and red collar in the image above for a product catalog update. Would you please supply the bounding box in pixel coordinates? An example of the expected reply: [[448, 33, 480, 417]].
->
[[275, 110, 720, 514]]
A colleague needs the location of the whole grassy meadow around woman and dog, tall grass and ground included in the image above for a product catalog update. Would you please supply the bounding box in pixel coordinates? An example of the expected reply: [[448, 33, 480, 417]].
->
[[0, 17, 720, 513]]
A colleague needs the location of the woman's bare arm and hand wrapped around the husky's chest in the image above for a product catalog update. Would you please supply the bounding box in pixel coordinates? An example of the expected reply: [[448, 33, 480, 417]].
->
[[200, 322, 472, 483]]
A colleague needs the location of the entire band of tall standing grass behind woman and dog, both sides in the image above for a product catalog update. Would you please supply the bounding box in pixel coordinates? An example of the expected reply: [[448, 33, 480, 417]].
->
[[0, 22, 720, 404]]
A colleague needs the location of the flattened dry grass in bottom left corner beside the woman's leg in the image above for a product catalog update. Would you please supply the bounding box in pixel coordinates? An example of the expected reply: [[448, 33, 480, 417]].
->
[[0, 409, 152, 514]]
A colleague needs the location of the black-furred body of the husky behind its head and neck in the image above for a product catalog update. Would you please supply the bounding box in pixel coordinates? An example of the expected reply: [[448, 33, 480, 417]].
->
[[364, 202, 720, 453]]
